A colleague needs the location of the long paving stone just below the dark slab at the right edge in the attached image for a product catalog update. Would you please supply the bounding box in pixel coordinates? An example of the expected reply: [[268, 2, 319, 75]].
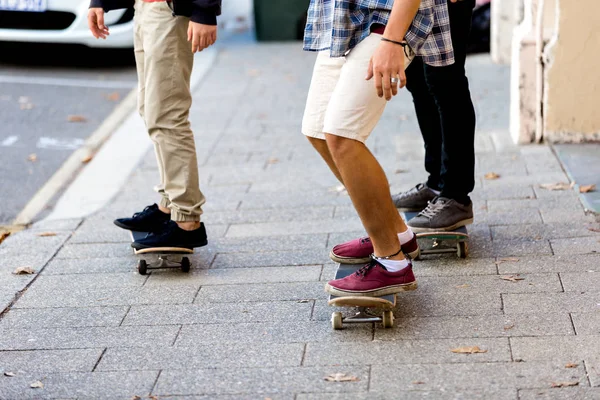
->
[[492, 220, 600, 240]]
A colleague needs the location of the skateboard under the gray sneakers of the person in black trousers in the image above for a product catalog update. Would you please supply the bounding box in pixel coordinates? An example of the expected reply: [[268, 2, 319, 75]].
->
[[403, 212, 469, 258]]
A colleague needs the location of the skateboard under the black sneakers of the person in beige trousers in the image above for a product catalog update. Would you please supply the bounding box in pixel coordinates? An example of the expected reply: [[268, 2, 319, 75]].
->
[[131, 231, 194, 275]]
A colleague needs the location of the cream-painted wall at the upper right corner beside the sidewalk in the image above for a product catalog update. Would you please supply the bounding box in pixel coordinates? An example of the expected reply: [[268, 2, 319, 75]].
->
[[544, 0, 600, 142]]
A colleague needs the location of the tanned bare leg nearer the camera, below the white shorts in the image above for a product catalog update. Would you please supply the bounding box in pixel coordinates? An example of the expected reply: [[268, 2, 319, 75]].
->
[[325, 134, 406, 260]]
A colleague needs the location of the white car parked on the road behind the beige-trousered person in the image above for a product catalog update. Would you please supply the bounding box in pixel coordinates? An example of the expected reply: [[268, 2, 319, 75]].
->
[[0, 0, 133, 48]]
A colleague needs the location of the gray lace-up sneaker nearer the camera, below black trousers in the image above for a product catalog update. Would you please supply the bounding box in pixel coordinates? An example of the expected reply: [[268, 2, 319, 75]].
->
[[407, 197, 473, 232]]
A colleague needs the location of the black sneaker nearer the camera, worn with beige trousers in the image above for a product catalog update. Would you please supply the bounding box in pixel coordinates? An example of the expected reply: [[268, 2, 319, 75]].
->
[[131, 221, 208, 250]]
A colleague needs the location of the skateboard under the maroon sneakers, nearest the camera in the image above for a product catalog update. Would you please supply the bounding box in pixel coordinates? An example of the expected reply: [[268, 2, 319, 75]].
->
[[327, 264, 396, 330]]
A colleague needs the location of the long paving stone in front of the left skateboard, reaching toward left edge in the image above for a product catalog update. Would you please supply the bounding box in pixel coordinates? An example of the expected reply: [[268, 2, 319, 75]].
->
[[14, 284, 199, 308]]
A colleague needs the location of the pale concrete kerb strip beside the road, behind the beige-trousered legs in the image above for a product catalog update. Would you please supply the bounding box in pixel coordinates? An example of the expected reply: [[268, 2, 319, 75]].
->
[[40, 47, 217, 220]]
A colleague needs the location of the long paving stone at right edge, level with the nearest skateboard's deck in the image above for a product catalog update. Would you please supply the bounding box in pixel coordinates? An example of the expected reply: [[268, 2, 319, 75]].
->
[[502, 292, 600, 314]]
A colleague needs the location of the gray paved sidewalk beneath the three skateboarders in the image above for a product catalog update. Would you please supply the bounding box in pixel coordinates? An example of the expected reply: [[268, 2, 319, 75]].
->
[[0, 44, 600, 400]]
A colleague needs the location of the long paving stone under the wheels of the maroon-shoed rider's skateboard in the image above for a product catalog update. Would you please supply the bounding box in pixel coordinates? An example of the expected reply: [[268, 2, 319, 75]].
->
[[176, 318, 373, 346]]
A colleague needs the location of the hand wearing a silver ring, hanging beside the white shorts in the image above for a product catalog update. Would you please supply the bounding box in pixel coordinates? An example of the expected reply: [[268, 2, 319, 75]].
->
[[366, 41, 406, 100]]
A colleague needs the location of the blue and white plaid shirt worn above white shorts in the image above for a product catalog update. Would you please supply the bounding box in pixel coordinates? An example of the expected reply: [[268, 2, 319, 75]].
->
[[304, 0, 454, 66]]
